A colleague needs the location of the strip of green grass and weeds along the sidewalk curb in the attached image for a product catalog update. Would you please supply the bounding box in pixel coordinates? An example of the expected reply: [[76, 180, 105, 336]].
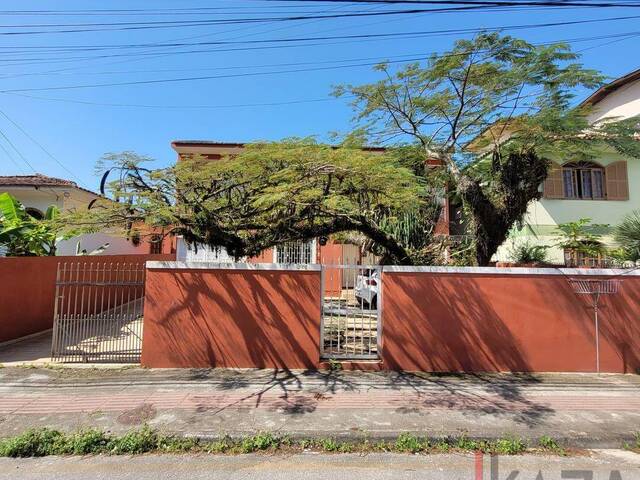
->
[[0, 426, 568, 457]]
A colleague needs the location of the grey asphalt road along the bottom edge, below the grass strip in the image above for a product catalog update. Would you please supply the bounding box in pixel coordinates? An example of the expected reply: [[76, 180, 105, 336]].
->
[[0, 450, 640, 480]]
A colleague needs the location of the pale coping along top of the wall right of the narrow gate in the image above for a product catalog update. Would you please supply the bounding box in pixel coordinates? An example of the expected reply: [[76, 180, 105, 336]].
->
[[382, 265, 640, 277]]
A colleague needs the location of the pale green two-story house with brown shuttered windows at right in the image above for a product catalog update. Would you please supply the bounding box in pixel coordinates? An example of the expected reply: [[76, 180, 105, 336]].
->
[[496, 69, 640, 264]]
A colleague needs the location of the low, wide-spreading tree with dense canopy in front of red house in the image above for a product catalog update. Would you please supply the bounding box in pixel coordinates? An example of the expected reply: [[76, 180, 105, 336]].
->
[[67, 140, 438, 264]]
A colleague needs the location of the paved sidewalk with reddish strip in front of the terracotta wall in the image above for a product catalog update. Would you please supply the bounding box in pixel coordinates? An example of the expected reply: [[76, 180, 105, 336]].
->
[[0, 368, 640, 448]]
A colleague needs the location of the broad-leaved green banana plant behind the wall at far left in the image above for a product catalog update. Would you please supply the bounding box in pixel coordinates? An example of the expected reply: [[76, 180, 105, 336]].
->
[[0, 192, 59, 256]]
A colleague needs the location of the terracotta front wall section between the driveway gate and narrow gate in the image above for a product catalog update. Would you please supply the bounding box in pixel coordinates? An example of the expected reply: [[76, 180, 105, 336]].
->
[[142, 266, 320, 368]]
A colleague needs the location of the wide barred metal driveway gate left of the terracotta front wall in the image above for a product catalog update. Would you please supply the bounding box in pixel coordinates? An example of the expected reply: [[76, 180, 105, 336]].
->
[[51, 261, 145, 363]]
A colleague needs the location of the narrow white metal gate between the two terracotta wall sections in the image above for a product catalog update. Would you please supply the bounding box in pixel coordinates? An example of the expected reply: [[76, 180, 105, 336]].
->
[[321, 265, 382, 360]]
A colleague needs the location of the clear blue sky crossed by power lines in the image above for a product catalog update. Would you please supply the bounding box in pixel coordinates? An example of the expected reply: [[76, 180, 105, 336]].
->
[[0, 0, 640, 189]]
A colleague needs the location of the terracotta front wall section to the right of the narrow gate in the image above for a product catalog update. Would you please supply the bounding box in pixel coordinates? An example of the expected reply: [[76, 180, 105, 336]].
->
[[382, 272, 640, 372]]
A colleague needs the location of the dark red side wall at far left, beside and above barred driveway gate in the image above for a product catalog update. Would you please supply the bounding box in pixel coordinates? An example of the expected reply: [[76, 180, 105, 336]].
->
[[0, 255, 175, 343]]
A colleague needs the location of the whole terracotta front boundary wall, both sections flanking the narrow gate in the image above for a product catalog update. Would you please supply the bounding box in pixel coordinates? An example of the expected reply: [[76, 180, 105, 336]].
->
[[142, 264, 640, 373]]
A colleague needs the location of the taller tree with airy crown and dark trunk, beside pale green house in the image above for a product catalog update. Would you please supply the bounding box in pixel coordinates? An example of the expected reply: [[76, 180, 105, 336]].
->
[[335, 33, 640, 265]]
